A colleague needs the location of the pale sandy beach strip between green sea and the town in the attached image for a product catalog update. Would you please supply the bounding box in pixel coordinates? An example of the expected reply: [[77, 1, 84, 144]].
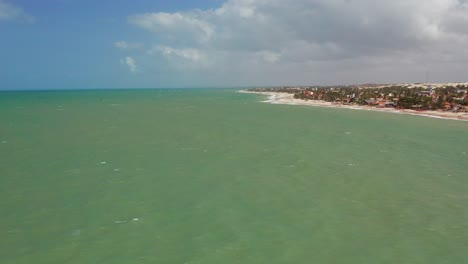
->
[[239, 90, 468, 121]]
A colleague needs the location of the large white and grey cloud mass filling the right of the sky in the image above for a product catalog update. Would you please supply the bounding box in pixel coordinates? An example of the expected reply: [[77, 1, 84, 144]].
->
[[128, 0, 468, 83]]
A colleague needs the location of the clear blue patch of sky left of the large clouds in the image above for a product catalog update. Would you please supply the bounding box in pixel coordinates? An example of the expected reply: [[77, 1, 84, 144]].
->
[[0, 0, 223, 89]]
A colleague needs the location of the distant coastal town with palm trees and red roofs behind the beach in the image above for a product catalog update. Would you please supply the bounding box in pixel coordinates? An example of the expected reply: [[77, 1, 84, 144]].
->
[[249, 83, 468, 113]]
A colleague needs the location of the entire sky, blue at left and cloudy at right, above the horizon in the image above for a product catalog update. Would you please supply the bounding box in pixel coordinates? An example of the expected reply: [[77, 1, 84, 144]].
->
[[0, 0, 468, 90]]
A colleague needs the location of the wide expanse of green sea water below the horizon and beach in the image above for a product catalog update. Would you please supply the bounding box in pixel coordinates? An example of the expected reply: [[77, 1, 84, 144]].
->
[[0, 89, 468, 264]]
